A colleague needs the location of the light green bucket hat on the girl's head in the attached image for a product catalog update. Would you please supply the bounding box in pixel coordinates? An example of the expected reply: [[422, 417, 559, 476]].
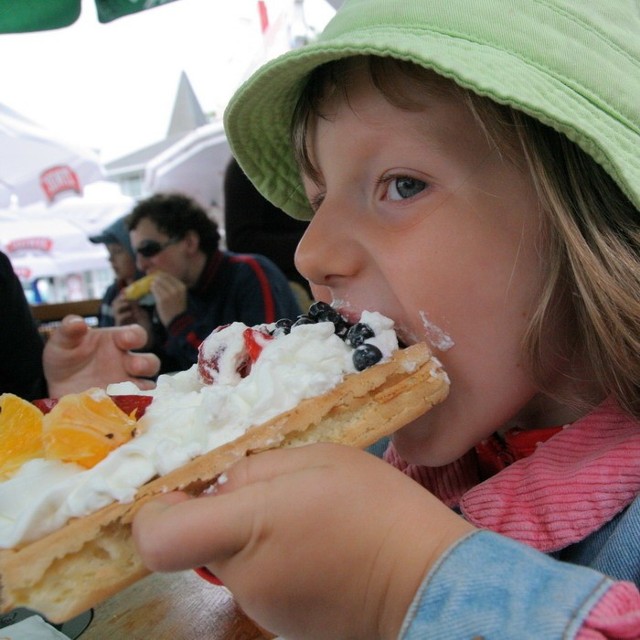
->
[[225, 0, 640, 219]]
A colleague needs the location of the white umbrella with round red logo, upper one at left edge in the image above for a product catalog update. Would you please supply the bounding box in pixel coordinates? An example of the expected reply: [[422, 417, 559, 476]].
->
[[0, 104, 105, 207]]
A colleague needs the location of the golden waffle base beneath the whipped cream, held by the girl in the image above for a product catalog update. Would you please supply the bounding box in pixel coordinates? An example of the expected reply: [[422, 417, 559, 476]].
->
[[0, 344, 449, 623]]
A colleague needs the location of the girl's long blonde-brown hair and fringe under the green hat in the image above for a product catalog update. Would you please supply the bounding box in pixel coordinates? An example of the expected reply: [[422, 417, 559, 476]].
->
[[291, 56, 640, 417]]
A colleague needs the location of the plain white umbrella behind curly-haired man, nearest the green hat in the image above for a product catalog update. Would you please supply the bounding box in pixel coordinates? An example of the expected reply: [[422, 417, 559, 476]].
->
[[144, 122, 231, 208]]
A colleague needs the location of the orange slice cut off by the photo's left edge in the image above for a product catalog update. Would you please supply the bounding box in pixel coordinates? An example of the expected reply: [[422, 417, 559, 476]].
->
[[0, 393, 43, 480]]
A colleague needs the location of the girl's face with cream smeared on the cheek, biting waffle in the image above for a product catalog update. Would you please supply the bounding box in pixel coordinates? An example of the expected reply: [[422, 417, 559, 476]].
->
[[296, 72, 567, 466]]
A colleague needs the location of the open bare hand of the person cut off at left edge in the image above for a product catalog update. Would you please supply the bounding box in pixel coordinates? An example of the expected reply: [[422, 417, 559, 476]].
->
[[42, 316, 160, 397]]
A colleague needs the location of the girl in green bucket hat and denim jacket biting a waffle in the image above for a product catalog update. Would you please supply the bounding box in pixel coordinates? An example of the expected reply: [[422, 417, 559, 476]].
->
[[135, 0, 640, 638]]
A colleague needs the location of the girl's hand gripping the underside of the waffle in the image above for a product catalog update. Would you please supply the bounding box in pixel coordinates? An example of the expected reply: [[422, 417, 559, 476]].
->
[[133, 445, 472, 638]]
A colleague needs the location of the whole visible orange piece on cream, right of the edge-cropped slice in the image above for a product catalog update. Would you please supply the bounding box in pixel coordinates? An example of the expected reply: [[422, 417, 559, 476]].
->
[[42, 389, 136, 469]]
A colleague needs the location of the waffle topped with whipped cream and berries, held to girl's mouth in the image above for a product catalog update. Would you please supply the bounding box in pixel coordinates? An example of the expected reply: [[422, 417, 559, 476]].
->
[[0, 303, 448, 622]]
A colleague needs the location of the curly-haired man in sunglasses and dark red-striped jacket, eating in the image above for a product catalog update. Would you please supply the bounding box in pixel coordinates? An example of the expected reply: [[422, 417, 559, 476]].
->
[[121, 194, 302, 372]]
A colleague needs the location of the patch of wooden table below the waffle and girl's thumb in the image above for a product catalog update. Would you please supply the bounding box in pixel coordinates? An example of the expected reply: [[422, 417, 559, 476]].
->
[[80, 571, 272, 640]]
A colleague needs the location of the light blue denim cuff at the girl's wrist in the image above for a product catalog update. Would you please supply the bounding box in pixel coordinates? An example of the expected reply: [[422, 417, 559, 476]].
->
[[399, 531, 612, 640]]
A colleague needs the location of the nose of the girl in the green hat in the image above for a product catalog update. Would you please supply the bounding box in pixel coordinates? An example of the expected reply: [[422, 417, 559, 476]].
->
[[295, 202, 360, 287]]
